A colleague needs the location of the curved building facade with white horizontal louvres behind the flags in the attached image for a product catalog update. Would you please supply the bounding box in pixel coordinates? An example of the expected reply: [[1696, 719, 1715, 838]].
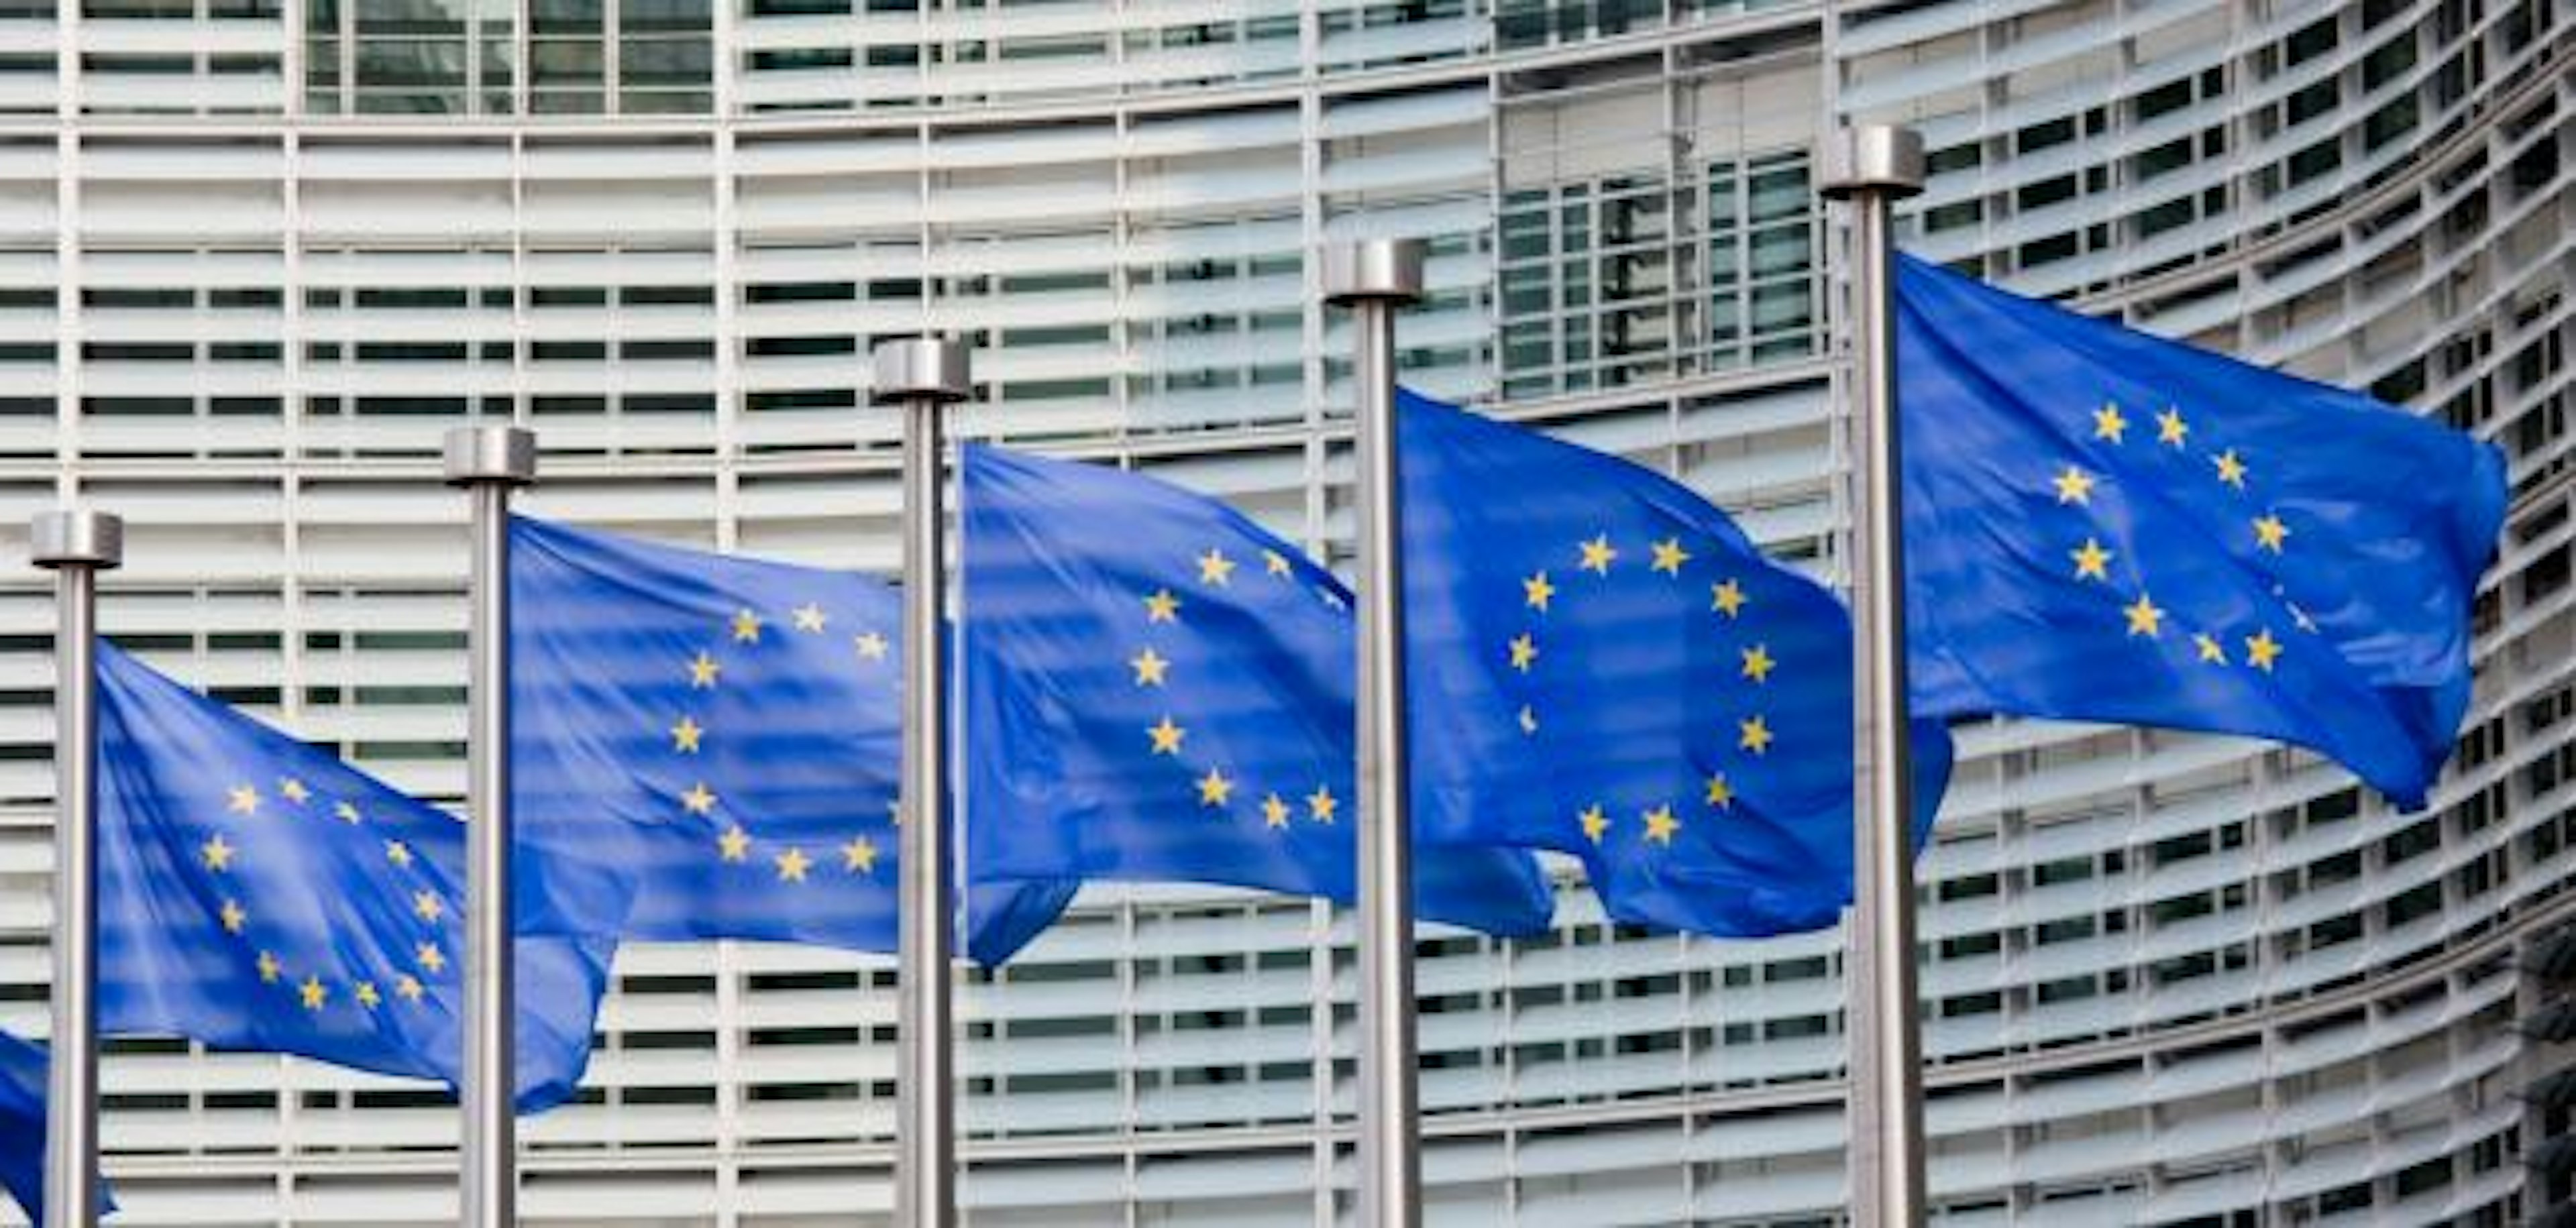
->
[[0, 0, 2576, 1228]]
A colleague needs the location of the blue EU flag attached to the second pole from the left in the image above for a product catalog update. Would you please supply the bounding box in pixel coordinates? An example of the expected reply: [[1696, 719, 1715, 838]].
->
[[510, 518, 1074, 963]]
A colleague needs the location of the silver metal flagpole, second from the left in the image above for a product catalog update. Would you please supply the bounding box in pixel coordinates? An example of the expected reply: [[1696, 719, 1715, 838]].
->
[[445, 425, 536, 1228]]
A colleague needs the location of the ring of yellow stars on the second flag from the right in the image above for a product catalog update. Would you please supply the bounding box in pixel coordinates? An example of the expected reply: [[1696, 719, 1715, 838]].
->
[[1502, 533, 1780, 850]]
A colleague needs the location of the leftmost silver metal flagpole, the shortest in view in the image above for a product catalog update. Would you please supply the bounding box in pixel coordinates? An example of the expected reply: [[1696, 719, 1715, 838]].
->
[[28, 510, 126, 1228]]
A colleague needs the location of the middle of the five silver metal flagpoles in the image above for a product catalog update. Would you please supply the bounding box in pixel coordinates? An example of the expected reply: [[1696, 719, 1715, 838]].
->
[[868, 337, 971, 1228]]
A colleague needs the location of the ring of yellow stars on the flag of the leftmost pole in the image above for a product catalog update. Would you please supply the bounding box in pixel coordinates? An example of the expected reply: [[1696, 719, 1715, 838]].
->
[[196, 775, 453, 1014]]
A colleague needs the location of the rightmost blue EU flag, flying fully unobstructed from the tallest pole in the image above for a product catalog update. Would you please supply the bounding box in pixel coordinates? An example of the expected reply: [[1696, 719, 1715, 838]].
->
[[1896, 258, 2506, 805]]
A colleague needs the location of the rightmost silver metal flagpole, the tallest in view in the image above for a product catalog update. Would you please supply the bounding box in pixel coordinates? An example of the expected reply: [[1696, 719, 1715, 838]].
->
[[1821, 123, 1924, 1228]]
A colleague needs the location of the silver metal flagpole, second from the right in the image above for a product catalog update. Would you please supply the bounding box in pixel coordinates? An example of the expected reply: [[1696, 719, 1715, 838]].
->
[[1324, 239, 1422, 1228]]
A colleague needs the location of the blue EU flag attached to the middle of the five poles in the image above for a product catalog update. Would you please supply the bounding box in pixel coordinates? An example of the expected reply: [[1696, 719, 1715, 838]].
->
[[958, 445, 1554, 934]]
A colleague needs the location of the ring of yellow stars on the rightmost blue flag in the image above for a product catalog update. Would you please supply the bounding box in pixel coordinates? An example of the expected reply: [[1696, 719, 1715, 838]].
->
[[2051, 402, 2316, 675]]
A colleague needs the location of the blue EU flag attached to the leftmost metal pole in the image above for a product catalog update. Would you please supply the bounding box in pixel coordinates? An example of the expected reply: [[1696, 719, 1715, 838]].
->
[[98, 641, 613, 1112]]
